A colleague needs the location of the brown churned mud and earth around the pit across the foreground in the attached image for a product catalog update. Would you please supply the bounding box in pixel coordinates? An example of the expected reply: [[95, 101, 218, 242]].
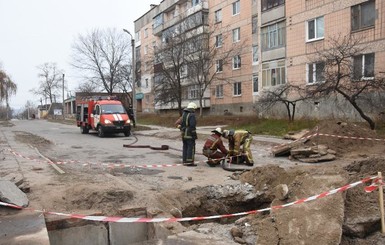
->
[[0, 122, 385, 245]]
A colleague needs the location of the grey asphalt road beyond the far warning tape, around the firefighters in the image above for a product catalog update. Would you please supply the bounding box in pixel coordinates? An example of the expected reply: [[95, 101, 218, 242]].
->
[[3, 120, 287, 169]]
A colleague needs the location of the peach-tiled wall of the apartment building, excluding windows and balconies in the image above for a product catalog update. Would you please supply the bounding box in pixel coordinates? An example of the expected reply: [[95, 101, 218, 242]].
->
[[135, 0, 385, 120]]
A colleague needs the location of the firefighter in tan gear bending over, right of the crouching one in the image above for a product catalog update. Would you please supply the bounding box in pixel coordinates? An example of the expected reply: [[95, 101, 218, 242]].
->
[[223, 129, 254, 166]]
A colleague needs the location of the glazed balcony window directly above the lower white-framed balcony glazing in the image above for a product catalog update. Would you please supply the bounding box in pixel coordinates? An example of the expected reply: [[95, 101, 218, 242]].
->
[[261, 21, 286, 50]]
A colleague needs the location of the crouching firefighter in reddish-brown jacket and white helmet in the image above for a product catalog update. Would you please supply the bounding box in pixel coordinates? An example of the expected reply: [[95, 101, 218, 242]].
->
[[202, 128, 228, 167]]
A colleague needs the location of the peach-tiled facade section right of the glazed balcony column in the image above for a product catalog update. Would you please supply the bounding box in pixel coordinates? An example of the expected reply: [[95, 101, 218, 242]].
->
[[285, 0, 385, 120]]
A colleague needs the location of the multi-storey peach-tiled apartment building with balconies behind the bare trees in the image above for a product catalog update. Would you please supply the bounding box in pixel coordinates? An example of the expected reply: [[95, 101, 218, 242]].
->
[[135, 0, 385, 118]]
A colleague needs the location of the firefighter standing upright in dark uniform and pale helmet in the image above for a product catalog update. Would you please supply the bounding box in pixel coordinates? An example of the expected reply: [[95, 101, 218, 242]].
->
[[175, 102, 198, 166]]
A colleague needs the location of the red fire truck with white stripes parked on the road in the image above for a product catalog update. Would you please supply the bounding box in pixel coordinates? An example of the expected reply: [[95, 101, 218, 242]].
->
[[76, 97, 131, 137]]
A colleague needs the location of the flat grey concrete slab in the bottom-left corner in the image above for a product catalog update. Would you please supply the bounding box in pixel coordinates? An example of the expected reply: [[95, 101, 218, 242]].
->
[[0, 210, 50, 245]]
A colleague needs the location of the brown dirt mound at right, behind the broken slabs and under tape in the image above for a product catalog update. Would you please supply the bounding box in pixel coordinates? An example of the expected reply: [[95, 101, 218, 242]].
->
[[303, 121, 384, 156]]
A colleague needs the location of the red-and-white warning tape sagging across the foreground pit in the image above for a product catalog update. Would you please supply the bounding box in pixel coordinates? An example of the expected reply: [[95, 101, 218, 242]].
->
[[0, 176, 382, 223]]
